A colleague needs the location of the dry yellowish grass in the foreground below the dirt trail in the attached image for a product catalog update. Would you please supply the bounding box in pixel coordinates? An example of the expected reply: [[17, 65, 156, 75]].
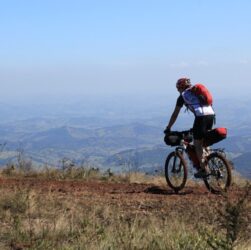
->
[[0, 186, 250, 250]]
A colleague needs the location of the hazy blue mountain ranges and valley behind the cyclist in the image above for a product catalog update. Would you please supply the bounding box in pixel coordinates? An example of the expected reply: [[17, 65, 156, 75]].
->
[[0, 97, 251, 178]]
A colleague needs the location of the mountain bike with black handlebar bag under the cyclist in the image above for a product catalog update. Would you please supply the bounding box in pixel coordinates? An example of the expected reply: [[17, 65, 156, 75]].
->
[[165, 128, 232, 193]]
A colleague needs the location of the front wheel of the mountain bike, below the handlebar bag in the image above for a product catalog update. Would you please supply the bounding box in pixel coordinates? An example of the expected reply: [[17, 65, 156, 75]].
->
[[165, 152, 187, 193]]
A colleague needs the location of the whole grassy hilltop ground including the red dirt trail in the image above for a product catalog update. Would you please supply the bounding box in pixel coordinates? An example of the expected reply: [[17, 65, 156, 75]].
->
[[0, 166, 251, 250]]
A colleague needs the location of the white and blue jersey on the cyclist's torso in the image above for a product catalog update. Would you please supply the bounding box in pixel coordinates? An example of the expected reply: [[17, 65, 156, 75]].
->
[[181, 89, 215, 116]]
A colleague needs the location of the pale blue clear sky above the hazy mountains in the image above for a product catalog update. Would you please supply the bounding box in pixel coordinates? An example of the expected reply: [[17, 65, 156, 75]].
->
[[0, 0, 251, 102]]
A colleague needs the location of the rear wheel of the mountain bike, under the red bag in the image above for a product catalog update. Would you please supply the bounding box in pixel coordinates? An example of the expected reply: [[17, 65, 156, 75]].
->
[[204, 152, 232, 194]]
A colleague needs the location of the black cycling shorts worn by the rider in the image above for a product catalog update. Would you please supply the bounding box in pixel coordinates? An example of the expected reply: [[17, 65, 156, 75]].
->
[[193, 115, 215, 140]]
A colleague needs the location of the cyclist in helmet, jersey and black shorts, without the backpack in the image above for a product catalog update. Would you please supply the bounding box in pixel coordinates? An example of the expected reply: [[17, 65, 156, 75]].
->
[[164, 78, 215, 178]]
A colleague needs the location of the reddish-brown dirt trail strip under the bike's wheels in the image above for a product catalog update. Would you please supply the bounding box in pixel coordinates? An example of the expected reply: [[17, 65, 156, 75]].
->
[[0, 178, 242, 201]]
